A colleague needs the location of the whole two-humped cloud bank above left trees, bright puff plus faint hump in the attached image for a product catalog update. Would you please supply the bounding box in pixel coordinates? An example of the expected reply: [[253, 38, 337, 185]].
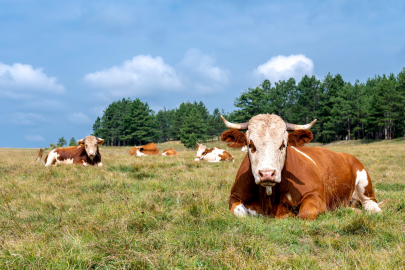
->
[[84, 49, 230, 97]]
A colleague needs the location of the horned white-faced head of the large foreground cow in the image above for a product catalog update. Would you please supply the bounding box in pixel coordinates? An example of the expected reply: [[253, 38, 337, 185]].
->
[[221, 114, 316, 195]]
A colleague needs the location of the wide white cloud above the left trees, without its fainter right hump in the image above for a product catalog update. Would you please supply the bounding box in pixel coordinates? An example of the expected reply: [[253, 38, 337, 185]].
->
[[84, 55, 182, 97]]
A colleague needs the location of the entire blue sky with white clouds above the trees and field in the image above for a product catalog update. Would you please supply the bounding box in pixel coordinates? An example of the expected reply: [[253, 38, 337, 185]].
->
[[0, 0, 405, 148]]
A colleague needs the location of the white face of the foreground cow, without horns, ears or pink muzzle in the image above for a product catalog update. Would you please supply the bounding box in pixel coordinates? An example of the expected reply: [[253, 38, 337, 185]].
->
[[246, 114, 288, 184]]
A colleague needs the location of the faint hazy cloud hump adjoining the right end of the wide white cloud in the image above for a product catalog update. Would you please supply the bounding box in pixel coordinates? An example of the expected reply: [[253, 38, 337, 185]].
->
[[179, 48, 230, 93]]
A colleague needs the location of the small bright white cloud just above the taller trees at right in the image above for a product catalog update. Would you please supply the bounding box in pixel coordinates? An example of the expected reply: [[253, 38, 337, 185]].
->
[[253, 54, 314, 82]]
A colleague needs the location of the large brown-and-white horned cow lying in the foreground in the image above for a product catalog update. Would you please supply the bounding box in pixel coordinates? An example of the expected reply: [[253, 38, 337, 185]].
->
[[221, 114, 381, 220]]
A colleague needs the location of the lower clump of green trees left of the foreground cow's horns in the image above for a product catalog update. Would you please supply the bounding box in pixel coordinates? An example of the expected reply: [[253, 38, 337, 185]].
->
[[93, 98, 226, 148]]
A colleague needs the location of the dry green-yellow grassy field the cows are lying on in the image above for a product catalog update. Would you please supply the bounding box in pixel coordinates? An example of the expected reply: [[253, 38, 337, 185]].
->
[[0, 139, 405, 269]]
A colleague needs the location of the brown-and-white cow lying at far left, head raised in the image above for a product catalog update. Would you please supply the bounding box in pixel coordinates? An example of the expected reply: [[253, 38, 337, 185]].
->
[[37, 136, 104, 167]]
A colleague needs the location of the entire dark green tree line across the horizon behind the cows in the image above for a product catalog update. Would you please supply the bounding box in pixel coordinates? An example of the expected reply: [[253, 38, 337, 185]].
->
[[93, 68, 405, 147]]
